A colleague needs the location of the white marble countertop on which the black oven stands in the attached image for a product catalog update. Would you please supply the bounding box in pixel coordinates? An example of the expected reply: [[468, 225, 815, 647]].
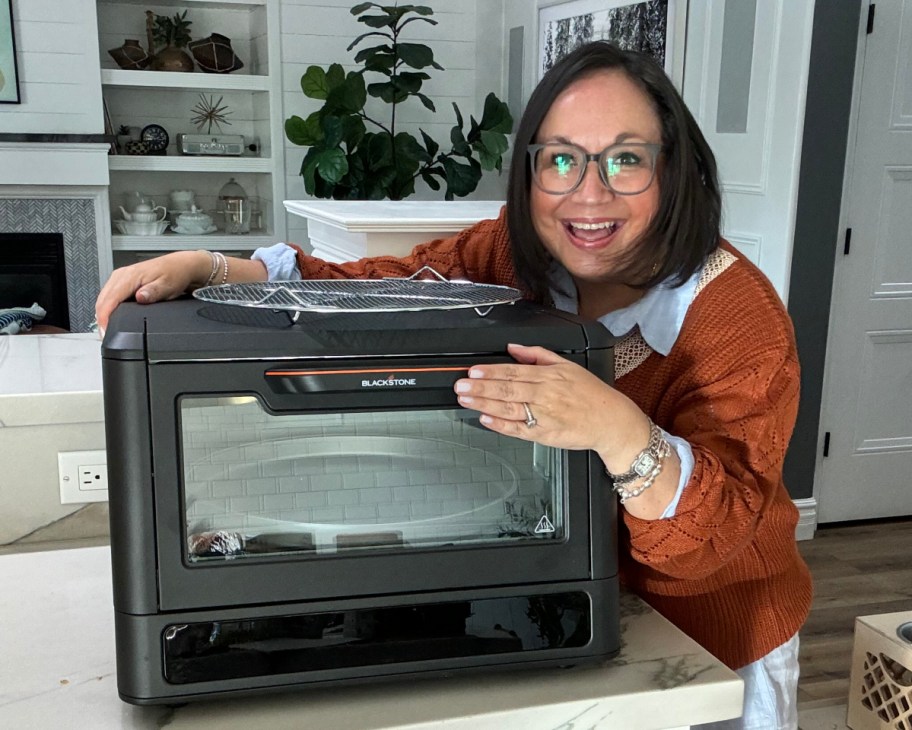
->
[[0, 547, 743, 730]]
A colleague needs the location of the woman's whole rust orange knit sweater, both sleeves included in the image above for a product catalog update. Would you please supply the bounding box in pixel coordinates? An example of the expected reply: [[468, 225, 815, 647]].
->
[[298, 211, 811, 669]]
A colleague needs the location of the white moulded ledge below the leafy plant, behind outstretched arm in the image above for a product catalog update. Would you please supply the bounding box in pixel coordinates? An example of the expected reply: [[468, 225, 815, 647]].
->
[[285, 200, 503, 263]]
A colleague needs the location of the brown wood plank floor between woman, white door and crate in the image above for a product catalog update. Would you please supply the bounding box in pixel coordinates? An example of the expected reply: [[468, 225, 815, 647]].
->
[[798, 519, 912, 706]]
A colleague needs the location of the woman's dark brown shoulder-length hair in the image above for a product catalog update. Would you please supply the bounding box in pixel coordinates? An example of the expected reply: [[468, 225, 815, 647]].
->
[[507, 41, 722, 301]]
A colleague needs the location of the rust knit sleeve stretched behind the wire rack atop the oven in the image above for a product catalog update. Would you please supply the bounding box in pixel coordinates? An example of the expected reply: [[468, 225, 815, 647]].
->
[[286, 209, 515, 286]]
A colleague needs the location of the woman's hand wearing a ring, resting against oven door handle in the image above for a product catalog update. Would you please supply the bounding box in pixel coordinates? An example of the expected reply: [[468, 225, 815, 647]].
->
[[455, 345, 649, 458]]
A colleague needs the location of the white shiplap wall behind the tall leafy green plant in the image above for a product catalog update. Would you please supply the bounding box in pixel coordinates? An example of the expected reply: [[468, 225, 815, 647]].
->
[[281, 0, 505, 243]]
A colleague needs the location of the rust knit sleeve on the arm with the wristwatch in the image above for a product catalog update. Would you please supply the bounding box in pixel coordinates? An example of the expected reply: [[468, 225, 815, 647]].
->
[[624, 264, 799, 579]]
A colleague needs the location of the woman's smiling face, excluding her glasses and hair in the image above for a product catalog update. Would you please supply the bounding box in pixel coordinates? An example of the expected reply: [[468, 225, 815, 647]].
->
[[530, 70, 662, 283]]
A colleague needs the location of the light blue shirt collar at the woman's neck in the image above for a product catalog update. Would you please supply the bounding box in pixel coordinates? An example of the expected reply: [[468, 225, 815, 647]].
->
[[550, 262, 702, 355]]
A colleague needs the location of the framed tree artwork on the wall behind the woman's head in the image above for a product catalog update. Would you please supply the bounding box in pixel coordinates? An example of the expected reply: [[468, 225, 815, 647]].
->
[[538, 0, 687, 89]]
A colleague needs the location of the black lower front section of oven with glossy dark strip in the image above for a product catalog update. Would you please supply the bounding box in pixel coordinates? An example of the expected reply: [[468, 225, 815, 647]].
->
[[116, 579, 619, 704]]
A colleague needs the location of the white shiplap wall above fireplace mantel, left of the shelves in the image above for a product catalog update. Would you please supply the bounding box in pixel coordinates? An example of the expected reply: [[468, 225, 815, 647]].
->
[[0, 0, 104, 134]]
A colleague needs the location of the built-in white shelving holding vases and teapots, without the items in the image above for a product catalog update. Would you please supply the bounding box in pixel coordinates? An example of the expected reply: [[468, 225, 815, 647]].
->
[[96, 0, 286, 260]]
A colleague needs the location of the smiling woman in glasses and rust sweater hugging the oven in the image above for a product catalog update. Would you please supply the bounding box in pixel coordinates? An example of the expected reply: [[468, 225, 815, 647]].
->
[[97, 43, 811, 730]]
